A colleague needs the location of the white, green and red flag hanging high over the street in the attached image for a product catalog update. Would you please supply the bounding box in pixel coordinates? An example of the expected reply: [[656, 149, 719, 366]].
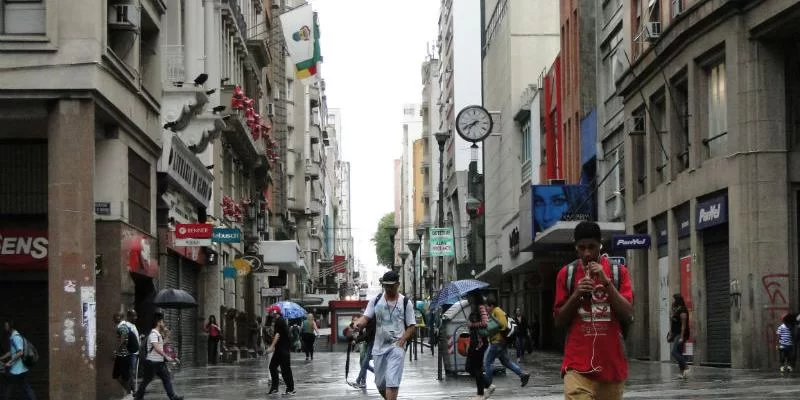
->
[[280, 5, 322, 84]]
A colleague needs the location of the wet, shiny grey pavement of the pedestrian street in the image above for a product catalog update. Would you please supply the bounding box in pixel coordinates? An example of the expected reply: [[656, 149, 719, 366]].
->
[[136, 346, 800, 400]]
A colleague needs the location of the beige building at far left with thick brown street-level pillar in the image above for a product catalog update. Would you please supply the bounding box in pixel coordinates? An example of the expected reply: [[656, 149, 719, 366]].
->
[[0, 0, 169, 399]]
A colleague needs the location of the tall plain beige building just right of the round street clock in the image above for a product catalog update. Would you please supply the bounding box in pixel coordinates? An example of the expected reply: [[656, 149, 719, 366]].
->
[[478, 0, 559, 313]]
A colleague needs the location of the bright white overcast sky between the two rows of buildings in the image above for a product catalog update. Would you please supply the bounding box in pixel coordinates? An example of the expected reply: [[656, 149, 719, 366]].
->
[[311, 0, 439, 274]]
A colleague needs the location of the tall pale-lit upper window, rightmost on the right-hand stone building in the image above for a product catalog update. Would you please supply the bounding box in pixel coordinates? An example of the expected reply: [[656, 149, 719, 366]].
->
[[703, 61, 728, 158]]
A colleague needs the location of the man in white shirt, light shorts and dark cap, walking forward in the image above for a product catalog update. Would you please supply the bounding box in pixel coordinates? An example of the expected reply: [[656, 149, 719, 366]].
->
[[354, 271, 417, 400]]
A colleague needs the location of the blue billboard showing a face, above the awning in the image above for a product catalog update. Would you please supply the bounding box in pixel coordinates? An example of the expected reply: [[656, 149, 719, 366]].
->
[[531, 185, 597, 235]]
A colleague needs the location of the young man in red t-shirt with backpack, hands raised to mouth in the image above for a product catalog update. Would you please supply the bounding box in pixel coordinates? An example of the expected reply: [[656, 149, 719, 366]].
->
[[553, 222, 633, 400]]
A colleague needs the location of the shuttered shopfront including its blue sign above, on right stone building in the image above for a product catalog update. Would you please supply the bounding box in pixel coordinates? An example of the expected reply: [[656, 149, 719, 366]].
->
[[695, 193, 731, 365]]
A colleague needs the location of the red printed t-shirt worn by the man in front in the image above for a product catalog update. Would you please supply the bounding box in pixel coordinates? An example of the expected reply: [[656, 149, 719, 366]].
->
[[553, 257, 633, 382]]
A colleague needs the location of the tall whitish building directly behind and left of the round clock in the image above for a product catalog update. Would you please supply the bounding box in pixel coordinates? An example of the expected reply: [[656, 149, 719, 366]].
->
[[436, 0, 482, 280]]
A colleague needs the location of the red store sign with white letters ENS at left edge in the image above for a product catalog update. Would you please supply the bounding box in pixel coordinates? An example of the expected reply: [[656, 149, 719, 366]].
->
[[0, 228, 49, 268]]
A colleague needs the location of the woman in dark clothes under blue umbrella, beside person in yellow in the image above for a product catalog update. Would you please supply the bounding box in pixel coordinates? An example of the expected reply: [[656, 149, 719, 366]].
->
[[466, 291, 493, 400]]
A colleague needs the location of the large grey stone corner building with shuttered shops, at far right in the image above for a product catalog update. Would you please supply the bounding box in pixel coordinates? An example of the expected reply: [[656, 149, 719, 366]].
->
[[616, 0, 800, 368]]
